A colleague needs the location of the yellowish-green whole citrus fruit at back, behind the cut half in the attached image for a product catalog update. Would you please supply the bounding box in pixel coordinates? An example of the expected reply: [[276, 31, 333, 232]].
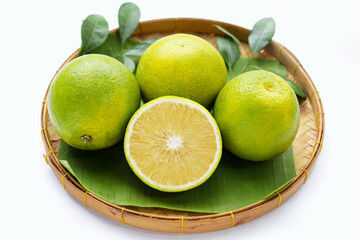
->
[[136, 34, 227, 108]]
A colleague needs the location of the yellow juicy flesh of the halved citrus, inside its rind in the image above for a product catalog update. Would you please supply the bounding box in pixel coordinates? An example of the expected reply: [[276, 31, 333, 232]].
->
[[129, 102, 218, 186]]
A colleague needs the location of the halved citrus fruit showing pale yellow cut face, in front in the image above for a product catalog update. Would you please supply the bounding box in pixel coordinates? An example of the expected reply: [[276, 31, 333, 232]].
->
[[124, 96, 222, 192]]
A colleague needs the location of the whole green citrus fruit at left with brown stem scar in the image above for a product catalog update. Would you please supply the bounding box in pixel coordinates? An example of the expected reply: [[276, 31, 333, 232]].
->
[[47, 54, 140, 150]]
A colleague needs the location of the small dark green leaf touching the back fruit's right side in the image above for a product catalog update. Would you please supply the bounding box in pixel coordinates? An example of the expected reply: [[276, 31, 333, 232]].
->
[[216, 37, 240, 69]]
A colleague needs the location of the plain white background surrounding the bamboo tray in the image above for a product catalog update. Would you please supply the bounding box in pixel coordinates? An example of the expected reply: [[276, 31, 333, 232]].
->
[[0, 0, 360, 240]]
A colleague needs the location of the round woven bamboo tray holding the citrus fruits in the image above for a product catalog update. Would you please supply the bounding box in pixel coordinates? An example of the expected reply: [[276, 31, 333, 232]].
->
[[41, 18, 324, 233]]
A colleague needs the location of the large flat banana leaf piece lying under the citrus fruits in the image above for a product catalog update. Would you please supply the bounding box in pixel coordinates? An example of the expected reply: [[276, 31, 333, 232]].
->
[[58, 141, 296, 213]]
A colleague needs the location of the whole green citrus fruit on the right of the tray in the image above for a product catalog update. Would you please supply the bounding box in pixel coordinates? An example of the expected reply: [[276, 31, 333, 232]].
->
[[214, 71, 300, 161]]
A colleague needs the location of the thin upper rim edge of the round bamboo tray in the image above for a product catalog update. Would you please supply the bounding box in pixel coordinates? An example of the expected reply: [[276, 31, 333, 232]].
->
[[41, 18, 325, 225]]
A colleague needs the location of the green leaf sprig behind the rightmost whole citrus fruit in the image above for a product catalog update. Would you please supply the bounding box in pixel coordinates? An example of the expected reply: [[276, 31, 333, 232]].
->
[[215, 18, 306, 98]]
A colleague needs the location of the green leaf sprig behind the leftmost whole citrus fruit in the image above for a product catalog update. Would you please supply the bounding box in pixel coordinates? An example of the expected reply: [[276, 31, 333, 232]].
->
[[79, 2, 159, 73]]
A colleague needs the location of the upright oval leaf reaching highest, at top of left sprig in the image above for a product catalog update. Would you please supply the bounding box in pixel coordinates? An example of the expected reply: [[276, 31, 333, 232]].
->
[[118, 2, 140, 43]]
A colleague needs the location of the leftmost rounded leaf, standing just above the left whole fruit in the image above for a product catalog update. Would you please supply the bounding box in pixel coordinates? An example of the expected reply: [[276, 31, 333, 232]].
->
[[79, 14, 109, 55]]
